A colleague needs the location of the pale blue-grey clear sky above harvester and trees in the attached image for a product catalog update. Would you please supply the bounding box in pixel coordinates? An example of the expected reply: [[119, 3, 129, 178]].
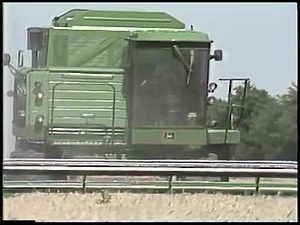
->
[[3, 2, 298, 156]]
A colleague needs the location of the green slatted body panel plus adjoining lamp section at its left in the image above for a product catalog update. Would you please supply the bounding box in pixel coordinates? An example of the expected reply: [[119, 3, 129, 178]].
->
[[26, 69, 126, 144]]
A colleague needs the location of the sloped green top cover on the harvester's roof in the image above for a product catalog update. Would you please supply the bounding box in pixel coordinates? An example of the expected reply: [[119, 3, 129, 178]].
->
[[53, 10, 184, 29]]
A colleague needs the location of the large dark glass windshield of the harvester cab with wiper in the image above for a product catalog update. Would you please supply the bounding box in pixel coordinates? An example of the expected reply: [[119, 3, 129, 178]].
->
[[132, 48, 208, 126]]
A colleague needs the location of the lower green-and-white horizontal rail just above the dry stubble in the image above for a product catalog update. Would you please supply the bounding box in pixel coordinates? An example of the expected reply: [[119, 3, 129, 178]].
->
[[3, 180, 298, 194]]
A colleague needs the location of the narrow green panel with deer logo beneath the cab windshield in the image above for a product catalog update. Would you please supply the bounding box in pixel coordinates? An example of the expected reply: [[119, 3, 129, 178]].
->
[[132, 127, 240, 145]]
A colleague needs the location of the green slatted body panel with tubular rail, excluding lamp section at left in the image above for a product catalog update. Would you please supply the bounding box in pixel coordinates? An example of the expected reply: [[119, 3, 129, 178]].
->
[[48, 70, 126, 144]]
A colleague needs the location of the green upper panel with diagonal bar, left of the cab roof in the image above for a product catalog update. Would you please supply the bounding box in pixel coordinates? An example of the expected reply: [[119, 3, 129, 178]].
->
[[50, 32, 128, 68]]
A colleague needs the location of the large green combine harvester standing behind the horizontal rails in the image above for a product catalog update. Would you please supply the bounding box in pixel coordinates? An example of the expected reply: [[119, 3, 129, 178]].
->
[[3, 10, 248, 176]]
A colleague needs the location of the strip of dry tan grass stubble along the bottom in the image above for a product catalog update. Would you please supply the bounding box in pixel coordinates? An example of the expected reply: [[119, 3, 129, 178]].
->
[[3, 193, 298, 221]]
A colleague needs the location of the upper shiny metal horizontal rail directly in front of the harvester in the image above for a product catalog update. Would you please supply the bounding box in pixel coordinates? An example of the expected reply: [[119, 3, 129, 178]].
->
[[3, 159, 298, 193]]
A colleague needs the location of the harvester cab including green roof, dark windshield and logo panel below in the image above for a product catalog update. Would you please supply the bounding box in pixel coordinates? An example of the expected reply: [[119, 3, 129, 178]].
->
[[124, 30, 238, 158]]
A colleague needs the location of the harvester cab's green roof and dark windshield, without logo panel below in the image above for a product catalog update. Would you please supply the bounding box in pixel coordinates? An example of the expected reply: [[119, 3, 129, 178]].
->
[[124, 31, 222, 128]]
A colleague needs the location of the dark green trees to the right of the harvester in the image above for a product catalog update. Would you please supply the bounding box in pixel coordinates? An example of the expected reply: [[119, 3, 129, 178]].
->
[[209, 83, 298, 160]]
